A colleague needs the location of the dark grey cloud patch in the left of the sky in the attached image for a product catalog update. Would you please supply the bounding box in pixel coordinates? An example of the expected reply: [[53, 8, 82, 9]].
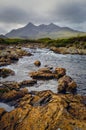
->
[[0, 7, 28, 23]]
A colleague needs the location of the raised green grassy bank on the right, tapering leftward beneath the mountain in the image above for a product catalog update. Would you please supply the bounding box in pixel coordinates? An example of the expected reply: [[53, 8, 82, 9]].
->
[[37, 36, 86, 49]]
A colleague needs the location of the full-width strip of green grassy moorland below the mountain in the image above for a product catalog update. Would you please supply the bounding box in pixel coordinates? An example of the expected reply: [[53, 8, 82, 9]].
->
[[0, 36, 86, 49]]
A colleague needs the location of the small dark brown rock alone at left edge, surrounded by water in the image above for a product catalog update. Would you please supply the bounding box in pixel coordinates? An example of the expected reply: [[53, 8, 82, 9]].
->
[[0, 68, 15, 78]]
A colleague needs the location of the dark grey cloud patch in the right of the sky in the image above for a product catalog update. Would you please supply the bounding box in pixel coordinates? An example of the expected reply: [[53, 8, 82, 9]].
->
[[52, 2, 86, 24]]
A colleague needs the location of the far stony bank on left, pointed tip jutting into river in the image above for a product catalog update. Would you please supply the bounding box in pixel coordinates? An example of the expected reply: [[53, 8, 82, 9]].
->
[[0, 45, 32, 66]]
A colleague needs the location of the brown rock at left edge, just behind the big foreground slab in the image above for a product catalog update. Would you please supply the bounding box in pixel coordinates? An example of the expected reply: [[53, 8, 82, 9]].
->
[[0, 81, 28, 102]]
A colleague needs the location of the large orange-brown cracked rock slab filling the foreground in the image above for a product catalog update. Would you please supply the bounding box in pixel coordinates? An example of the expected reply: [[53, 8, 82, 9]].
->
[[0, 91, 86, 130]]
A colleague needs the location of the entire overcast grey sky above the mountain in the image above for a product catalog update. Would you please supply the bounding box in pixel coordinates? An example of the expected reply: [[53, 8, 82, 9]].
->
[[0, 0, 86, 34]]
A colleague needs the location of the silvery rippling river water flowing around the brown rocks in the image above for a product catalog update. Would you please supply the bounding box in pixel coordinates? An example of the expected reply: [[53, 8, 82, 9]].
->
[[0, 48, 86, 95]]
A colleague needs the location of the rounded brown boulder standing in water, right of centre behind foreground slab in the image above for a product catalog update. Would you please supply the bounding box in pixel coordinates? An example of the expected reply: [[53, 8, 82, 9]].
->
[[58, 75, 77, 93]]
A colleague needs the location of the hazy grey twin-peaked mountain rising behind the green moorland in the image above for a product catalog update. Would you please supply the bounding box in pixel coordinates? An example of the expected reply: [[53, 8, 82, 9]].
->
[[5, 23, 85, 38]]
